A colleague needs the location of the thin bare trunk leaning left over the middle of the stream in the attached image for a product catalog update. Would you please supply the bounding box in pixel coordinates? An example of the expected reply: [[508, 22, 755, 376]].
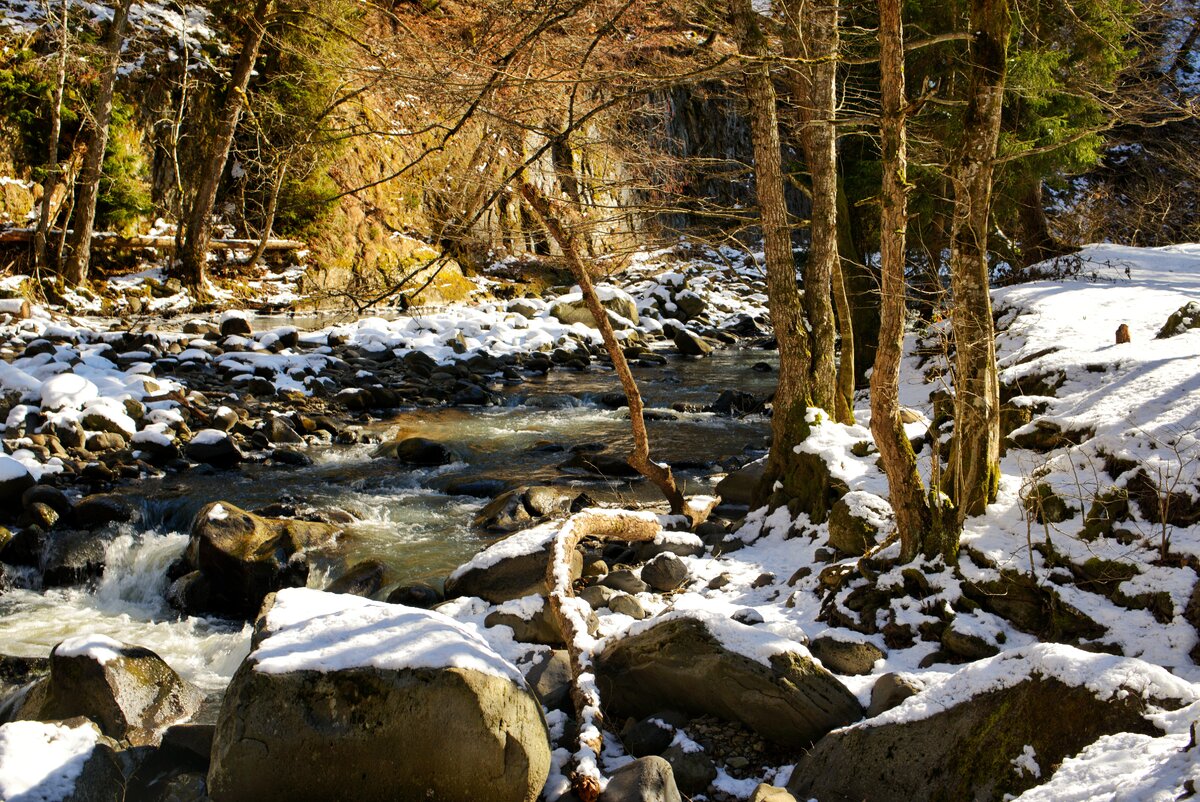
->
[[521, 181, 686, 515]]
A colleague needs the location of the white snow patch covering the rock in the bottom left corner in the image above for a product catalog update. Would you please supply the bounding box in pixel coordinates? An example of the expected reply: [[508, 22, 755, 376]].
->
[[0, 722, 100, 802]]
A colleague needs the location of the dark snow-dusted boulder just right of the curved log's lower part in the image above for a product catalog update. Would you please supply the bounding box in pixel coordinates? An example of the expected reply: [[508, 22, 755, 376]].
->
[[595, 612, 863, 748]]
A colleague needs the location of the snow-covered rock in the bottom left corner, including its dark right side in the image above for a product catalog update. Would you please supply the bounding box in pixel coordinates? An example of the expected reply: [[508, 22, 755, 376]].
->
[[0, 717, 127, 802]]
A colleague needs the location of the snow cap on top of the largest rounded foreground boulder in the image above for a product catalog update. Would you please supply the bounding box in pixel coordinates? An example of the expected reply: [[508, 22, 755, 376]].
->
[[250, 588, 524, 687]]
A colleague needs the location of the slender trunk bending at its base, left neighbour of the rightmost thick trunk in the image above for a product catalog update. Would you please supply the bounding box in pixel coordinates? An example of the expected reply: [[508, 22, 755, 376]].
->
[[871, 0, 931, 562]]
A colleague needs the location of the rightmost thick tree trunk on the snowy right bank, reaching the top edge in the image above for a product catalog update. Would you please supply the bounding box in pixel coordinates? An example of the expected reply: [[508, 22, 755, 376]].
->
[[948, 0, 1012, 533]]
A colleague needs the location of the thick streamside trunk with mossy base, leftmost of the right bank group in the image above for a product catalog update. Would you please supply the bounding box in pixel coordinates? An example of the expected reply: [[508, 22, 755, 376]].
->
[[733, 0, 823, 507]]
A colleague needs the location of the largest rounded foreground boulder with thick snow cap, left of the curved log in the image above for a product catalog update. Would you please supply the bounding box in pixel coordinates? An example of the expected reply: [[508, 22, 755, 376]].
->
[[209, 588, 550, 802]]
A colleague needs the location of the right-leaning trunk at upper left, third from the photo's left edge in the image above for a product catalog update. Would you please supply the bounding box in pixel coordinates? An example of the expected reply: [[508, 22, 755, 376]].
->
[[179, 0, 271, 291]]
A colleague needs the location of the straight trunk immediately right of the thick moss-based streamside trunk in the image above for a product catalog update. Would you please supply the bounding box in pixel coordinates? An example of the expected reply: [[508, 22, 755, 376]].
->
[[784, 0, 840, 423]]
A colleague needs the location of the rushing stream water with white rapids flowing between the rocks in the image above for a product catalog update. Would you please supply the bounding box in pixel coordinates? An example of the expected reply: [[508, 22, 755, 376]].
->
[[0, 351, 775, 690]]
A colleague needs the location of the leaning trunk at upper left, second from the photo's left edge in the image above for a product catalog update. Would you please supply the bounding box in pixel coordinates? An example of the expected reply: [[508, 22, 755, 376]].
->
[[62, 0, 133, 286]]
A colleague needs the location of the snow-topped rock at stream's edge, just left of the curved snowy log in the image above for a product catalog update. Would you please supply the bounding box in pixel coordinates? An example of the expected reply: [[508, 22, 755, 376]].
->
[[445, 527, 583, 604]]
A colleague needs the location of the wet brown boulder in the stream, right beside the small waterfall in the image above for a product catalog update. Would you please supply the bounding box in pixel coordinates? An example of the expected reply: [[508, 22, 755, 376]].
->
[[172, 502, 340, 620]]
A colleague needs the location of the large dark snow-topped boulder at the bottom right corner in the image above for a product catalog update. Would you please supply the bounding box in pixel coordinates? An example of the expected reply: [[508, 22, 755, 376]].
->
[[787, 644, 1200, 802]]
